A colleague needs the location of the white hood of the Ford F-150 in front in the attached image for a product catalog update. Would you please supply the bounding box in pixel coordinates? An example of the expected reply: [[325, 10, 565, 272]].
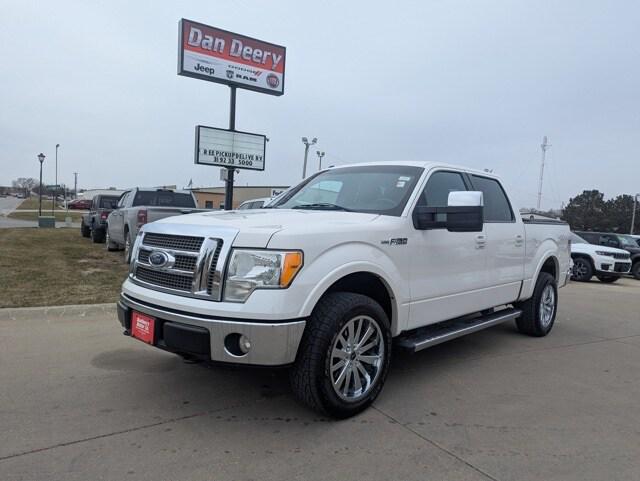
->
[[154, 209, 379, 248]]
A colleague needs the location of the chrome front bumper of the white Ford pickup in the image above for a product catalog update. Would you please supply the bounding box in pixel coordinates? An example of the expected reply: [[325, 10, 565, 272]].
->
[[118, 295, 306, 366]]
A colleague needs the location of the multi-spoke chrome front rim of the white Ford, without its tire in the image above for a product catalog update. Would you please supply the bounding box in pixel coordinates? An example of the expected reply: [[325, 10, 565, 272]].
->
[[329, 316, 386, 402]]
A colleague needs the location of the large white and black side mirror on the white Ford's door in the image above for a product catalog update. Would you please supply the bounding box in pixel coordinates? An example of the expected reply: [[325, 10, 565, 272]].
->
[[413, 191, 484, 232]]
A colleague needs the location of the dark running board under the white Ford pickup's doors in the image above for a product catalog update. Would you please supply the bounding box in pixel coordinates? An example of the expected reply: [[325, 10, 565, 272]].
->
[[397, 308, 522, 352]]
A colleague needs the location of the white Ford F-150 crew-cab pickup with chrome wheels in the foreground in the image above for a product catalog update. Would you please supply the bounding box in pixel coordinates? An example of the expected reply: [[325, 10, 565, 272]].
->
[[118, 162, 570, 418]]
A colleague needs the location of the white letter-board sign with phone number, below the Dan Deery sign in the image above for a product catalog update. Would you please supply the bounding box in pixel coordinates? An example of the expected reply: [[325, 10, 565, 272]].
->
[[195, 125, 267, 170]]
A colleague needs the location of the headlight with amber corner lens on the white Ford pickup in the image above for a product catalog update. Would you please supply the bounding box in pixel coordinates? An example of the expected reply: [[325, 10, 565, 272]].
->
[[223, 249, 302, 302]]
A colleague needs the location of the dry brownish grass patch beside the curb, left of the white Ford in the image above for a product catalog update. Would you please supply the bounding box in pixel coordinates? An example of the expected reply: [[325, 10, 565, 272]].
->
[[0, 228, 128, 307]]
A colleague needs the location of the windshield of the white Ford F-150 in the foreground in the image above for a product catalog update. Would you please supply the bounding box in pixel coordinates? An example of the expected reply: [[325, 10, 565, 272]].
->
[[269, 165, 424, 216]]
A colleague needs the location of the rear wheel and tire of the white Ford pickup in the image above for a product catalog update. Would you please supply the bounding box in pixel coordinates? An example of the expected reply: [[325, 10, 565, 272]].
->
[[515, 272, 558, 337]]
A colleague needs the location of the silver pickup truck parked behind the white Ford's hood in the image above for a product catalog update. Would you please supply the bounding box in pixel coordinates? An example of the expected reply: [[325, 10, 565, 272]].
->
[[106, 188, 208, 263]]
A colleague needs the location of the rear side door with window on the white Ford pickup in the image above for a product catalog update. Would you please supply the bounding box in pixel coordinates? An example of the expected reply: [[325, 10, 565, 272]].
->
[[469, 174, 525, 305]]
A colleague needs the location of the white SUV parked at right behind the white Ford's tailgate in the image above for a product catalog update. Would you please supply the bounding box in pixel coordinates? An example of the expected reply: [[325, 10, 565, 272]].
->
[[571, 234, 631, 283]]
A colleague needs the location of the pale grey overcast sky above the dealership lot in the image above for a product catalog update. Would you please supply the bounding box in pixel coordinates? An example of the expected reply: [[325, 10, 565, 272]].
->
[[0, 0, 640, 208]]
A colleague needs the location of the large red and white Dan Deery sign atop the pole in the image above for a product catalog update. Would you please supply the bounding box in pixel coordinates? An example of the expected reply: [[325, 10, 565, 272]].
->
[[178, 19, 286, 95]]
